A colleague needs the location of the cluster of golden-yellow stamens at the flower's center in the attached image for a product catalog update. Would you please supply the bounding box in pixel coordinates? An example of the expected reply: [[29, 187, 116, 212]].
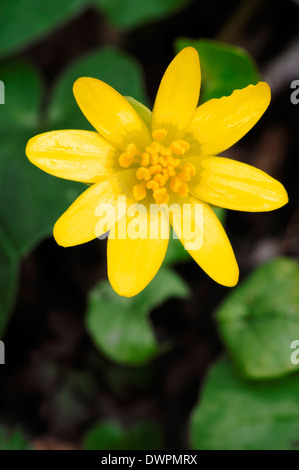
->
[[119, 129, 196, 204]]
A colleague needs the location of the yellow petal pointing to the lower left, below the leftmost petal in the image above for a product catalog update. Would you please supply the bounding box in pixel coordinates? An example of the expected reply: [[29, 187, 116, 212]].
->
[[53, 170, 136, 246]]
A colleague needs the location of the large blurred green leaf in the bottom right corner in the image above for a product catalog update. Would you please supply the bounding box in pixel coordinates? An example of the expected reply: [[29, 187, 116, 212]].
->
[[190, 359, 299, 450]]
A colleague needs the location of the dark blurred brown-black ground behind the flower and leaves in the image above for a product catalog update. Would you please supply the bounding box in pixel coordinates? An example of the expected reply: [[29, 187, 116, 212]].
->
[[0, 0, 299, 449]]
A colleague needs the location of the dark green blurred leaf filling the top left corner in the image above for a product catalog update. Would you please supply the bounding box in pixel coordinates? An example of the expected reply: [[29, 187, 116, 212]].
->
[[0, 0, 89, 56]]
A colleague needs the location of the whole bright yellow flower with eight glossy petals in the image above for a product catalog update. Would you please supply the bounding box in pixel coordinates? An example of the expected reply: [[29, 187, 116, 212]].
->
[[26, 47, 288, 297]]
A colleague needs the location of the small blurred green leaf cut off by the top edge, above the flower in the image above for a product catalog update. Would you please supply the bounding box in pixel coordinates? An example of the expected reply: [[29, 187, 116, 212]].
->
[[94, 0, 190, 30]]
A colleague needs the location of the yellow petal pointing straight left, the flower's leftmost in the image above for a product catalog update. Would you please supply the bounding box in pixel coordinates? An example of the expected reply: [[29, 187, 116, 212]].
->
[[26, 130, 120, 183]]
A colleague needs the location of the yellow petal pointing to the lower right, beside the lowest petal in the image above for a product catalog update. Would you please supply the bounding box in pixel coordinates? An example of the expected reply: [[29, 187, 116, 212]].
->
[[170, 196, 239, 287]]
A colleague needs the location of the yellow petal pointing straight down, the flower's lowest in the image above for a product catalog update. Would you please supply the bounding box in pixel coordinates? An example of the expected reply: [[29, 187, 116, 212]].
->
[[107, 204, 169, 297]]
